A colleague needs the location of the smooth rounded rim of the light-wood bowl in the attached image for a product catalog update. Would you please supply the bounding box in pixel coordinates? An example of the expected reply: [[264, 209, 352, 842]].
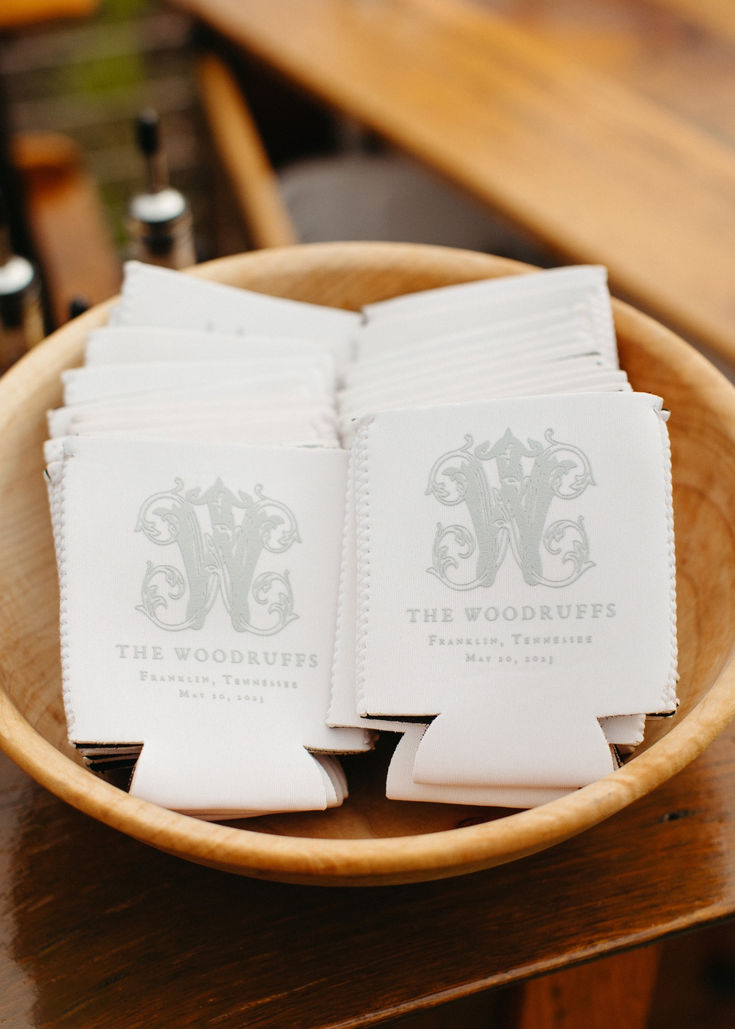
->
[[0, 243, 735, 885]]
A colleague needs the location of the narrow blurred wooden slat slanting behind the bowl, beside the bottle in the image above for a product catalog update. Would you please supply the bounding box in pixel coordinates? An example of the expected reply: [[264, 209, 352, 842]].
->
[[198, 55, 299, 248]]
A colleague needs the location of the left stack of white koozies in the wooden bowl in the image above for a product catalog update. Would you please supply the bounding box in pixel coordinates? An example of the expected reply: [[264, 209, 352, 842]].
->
[[46, 264, 370, 818]]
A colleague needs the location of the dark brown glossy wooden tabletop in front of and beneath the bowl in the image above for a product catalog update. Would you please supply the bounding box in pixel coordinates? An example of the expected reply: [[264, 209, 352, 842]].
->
[[0, 728, 735, 1029]]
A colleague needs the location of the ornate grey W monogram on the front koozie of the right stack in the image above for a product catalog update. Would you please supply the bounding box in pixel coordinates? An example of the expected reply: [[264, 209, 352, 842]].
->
[[426, 429, 594, 590]]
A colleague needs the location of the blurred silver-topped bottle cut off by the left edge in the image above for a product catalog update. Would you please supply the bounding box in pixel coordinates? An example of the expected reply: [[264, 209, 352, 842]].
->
[[0, 191, 43, 374]]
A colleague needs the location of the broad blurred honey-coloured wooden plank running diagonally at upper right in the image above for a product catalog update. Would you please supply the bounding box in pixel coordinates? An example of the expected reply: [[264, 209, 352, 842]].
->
[[169, 0, 735, 366]]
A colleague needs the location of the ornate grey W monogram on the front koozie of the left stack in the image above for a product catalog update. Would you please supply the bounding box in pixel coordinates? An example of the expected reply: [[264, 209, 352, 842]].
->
[[136, 478, 301, 636]]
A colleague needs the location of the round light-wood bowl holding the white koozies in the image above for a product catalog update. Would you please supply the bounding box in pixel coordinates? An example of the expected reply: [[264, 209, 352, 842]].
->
[[0, 244, 735, 885]]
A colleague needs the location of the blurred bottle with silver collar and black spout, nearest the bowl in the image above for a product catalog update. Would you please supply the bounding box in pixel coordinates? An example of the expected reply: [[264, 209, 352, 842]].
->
[[128, 110, 197, 269]]
